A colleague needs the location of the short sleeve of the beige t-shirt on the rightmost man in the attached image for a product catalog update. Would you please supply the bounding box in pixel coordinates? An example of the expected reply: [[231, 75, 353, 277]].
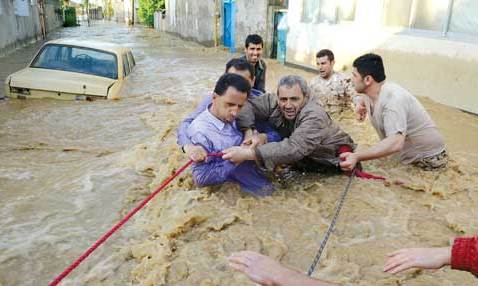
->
[[382, 102, 407, 137]]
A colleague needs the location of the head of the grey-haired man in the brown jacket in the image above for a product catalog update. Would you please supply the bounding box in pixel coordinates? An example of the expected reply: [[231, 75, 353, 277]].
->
[[277, 75, 310, 120]]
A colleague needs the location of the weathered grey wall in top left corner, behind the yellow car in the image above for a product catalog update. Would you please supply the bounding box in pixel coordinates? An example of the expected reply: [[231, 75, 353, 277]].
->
[[0, 0, 63, 55]]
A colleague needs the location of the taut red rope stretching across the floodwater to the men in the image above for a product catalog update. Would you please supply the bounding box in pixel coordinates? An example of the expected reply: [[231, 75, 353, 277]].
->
[[48, 153, 223, 286]]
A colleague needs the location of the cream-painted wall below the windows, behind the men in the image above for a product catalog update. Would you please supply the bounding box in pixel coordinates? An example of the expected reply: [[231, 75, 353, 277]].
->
[[286, 1, 478, 114]]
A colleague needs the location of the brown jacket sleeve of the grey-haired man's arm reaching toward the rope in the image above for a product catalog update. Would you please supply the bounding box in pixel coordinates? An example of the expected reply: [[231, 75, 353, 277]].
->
[[256, 111, 326, 170]]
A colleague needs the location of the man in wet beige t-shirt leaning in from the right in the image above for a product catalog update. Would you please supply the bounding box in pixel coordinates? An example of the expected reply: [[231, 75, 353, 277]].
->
[[340, 54, 448, 170]]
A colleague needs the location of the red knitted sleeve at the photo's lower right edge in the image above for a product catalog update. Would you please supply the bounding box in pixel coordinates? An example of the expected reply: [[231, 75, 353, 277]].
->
[[451, 236, 478, 277]]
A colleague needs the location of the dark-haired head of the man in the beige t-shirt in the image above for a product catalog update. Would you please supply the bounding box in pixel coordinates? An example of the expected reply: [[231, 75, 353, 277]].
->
[[352, 54, 386, 93]]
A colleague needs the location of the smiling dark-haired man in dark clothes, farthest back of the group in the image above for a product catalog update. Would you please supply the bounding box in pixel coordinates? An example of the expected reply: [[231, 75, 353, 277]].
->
[[241, 34, 267, 92]]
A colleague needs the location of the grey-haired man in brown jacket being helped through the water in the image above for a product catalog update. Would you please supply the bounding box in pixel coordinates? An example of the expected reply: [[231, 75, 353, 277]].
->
[[223, 75, 355, 171]]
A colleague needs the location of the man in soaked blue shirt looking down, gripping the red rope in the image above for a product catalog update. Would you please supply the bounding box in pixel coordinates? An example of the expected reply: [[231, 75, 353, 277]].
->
[[187, 73, 274, 196]]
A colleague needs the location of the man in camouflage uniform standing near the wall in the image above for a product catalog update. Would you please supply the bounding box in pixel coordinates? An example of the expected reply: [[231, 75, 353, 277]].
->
[[310, 49, 357, 114]]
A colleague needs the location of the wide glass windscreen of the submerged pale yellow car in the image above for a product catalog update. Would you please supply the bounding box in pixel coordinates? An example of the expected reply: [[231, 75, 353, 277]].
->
[[31, 44, 118, 79]]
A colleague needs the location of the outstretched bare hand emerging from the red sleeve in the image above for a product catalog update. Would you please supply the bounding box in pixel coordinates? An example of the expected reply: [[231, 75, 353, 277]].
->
[[383, 247, 451, 274]]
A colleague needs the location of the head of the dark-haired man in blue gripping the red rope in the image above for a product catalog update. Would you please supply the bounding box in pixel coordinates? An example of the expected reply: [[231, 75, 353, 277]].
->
[[210, 73, 251, 122]]
